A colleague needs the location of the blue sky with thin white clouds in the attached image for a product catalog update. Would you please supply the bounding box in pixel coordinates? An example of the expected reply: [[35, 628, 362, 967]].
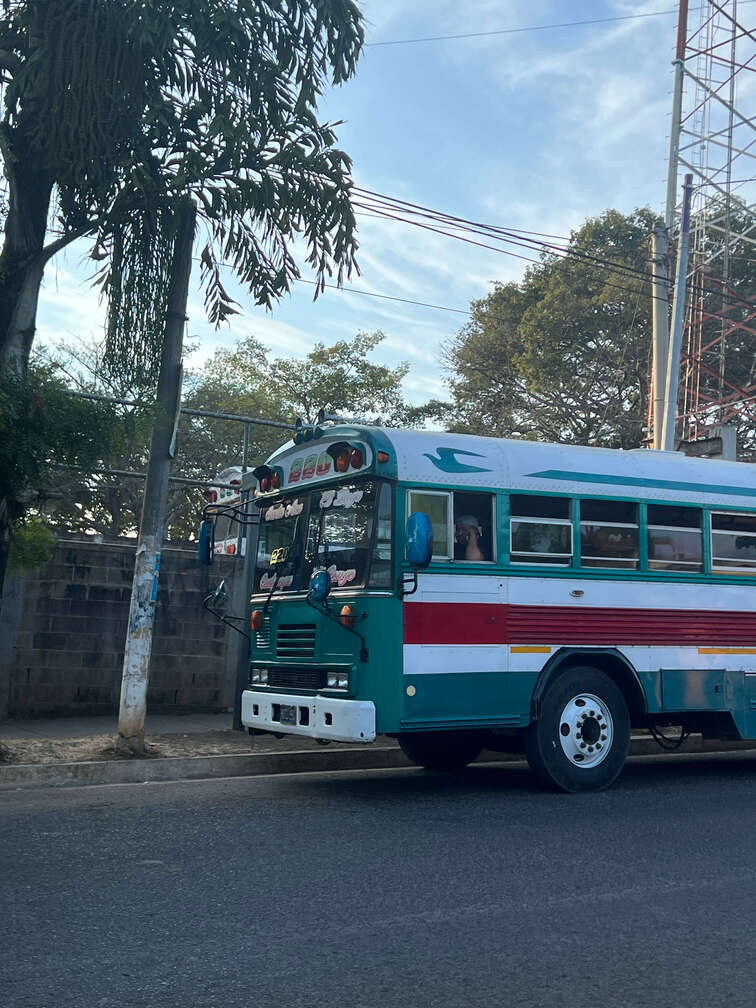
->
[[38, 0, 676, 403]]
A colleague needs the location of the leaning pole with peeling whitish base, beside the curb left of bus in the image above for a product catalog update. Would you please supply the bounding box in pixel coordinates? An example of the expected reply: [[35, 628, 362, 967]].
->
[[117, 197, 197, 755]]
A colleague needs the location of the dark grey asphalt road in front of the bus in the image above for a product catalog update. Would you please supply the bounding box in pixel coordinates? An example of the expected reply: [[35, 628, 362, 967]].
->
[[0, 753, 756, 1008]]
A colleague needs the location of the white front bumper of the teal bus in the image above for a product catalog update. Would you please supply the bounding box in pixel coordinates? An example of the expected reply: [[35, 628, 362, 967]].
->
[[242, 689, 375, 742]]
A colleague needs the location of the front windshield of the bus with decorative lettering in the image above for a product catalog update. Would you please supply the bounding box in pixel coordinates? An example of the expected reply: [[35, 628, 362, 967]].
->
[[254, 481, 391, 593]]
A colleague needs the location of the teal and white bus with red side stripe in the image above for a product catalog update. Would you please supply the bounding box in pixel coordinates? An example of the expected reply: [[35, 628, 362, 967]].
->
[[215, 423, 756, 791]]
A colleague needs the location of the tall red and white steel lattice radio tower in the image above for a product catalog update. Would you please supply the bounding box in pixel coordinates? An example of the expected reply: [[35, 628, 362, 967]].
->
[[665, 0, 756, 458]]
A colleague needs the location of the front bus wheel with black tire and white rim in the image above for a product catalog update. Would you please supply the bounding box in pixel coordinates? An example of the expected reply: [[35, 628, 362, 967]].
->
[[525, 667, 630, 791]]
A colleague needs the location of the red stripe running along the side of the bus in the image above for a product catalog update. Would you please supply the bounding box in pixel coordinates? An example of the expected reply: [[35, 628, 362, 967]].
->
[[404, 602, 756, 646]]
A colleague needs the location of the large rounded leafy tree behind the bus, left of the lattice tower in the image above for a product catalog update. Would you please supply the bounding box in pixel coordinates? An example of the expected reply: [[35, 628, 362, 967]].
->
[[435, 210, 654, 448]]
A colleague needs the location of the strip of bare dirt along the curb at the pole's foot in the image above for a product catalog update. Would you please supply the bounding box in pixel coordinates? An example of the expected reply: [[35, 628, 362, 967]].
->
[[0, 730, 392, 763]]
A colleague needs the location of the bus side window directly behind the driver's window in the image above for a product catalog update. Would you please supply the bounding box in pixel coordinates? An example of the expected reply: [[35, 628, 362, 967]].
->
[[510, 494, 573, 566]]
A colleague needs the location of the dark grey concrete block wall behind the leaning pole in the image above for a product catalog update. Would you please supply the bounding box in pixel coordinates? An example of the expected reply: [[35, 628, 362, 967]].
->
[[0, 539, 240, 718]]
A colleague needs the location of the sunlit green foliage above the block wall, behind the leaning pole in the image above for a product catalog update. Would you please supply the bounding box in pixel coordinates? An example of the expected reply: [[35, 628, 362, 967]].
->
[[35, 333, 407, 539]]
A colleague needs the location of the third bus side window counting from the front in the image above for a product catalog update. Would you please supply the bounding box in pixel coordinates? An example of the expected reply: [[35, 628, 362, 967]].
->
[[580, 500, 640, 571]]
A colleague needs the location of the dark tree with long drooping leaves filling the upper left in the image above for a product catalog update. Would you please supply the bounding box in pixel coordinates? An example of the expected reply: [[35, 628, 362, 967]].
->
[[0, 0, 364, 596]]
